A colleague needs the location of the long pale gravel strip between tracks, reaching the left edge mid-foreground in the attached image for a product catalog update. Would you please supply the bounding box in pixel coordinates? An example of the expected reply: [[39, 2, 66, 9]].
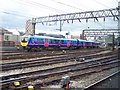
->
[[0, 57, 116, 77]]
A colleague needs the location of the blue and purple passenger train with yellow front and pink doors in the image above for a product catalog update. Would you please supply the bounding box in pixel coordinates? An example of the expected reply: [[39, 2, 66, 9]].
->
[[21, 35, 99, 51]]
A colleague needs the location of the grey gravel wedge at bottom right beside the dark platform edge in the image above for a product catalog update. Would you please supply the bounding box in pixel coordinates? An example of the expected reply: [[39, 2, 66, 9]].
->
[[71, 68, 118, 88]]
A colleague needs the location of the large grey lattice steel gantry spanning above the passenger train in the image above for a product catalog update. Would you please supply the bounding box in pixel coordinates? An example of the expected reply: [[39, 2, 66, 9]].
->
[[26, 8, 120, 34]]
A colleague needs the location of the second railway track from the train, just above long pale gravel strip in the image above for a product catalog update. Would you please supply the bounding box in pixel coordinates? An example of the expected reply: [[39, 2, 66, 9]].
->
[[1, 49, 116, 71]]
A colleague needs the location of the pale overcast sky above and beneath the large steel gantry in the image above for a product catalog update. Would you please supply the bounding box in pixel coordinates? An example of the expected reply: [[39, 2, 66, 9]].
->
[[0, 0, 119, 33]]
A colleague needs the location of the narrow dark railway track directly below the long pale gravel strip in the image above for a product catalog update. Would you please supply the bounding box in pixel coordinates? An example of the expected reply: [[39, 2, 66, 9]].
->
[[2, 56, 116, 79]]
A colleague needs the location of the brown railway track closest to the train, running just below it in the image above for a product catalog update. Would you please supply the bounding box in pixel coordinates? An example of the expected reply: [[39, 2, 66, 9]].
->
[[2, 49, 109, 60]]
